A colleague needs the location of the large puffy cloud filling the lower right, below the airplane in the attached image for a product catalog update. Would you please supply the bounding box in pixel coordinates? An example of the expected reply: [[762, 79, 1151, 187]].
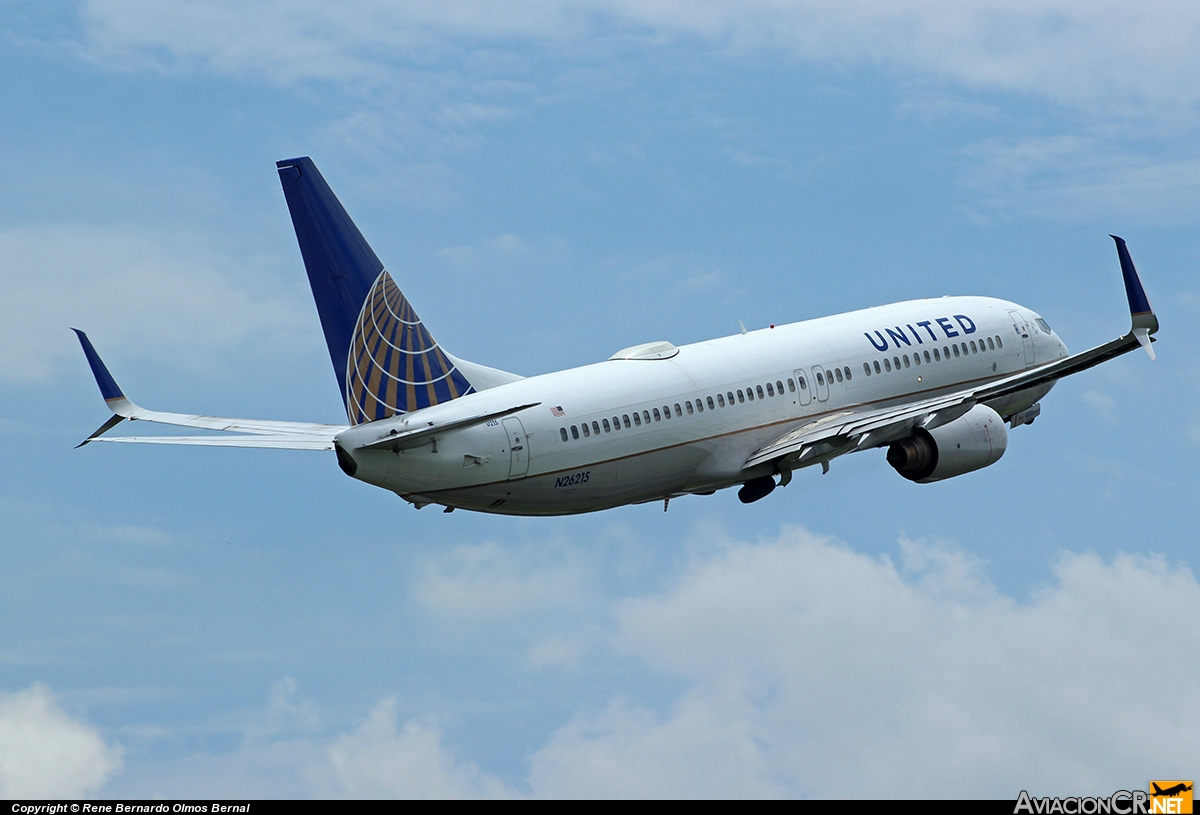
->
[[532, 528, 1200, 797]]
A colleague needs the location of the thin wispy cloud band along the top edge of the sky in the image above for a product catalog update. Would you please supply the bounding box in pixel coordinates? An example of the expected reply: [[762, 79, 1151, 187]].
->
[[72, 0, 1200, 120]]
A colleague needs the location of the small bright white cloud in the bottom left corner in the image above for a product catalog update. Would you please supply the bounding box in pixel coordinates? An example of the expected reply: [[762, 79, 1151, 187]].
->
[[0, 684, 121, 798]]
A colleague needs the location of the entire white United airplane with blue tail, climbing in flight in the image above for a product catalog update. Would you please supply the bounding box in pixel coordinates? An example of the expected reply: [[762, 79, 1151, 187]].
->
[[76, 158, 1158, 515]]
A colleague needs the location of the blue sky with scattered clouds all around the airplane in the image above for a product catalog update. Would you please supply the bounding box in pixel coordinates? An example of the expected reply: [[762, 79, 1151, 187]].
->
[[0, 0, 1200, 797]]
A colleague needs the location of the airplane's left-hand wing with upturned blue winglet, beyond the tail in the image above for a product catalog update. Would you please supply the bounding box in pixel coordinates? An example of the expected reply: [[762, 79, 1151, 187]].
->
[[71, 329, 347, 450]]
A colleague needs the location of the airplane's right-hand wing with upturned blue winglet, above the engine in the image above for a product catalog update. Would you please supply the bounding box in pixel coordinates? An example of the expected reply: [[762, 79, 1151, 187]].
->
[[744, 235, 1158, 478]]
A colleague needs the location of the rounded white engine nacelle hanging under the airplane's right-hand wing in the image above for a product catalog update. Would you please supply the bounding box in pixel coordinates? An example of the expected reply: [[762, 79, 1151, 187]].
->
[[888, 404, 1008, 484]]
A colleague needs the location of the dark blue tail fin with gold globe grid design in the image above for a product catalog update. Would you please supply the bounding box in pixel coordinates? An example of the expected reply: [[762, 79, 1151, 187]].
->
[[276, 157, 475, 425]]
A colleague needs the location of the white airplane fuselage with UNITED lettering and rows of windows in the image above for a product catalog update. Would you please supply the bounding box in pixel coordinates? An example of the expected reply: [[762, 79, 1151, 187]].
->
[[337, 296, 1067, 515]]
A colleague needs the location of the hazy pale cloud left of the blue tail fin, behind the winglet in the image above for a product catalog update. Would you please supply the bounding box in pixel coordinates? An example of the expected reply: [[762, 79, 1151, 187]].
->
[[0, 226, 314, 382]]
